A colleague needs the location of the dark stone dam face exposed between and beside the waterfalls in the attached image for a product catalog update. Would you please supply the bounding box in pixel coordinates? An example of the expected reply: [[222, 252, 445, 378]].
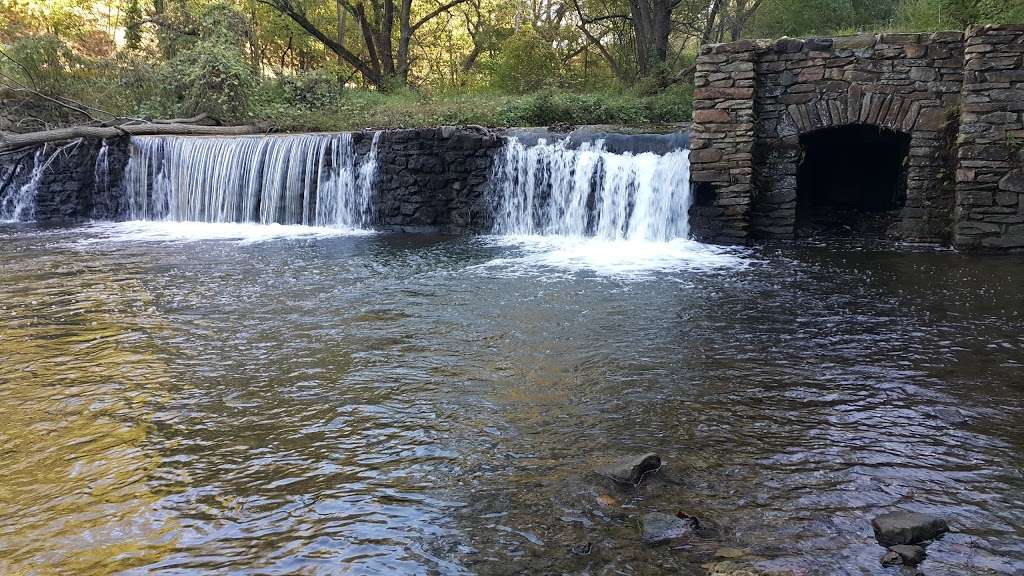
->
[[0, 127, 504, 233]]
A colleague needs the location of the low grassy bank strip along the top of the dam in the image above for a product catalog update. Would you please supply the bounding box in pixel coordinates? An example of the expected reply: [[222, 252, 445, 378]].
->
[[0, 84, 693, 132]]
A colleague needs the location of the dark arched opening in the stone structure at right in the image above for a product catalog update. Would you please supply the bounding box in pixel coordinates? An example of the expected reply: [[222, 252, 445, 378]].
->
[[797, 125, 910, 238]]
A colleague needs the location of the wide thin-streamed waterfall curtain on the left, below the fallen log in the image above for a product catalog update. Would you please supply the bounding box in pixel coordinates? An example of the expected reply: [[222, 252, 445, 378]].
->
[[125, 132, 380, 228]]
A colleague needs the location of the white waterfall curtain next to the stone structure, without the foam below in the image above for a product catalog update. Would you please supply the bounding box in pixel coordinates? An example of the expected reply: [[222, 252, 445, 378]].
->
[[493, 138, 690, 241]]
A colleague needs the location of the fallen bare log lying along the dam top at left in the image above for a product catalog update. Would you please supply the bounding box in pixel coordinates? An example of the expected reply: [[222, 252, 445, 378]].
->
[[0, 123, 269, 153]]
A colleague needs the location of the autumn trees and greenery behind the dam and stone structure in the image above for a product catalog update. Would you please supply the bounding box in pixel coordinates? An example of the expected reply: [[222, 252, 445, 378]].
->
[[0, 0, 1024, 132]]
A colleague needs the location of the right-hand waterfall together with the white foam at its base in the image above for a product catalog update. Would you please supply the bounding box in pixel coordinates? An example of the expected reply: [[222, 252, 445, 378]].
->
[[485, 139, 749, 277]]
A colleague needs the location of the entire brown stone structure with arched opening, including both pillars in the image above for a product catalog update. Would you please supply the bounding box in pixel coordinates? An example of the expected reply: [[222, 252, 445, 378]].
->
[[690, 26, 1024, 248]]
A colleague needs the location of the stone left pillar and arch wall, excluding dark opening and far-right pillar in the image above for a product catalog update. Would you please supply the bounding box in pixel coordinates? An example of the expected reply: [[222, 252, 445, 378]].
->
[[691, 32, 973, 241]]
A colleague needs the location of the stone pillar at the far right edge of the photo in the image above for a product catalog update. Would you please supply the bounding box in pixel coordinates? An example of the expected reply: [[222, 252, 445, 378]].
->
[[955, 26, 1024, 248]]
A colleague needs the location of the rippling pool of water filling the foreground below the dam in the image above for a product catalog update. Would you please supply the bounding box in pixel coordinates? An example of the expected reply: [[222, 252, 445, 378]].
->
[[0, 223, 1024, 576]]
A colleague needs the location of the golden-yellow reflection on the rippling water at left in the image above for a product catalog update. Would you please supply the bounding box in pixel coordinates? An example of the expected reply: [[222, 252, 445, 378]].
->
[[0, 239, 174, 574]]
